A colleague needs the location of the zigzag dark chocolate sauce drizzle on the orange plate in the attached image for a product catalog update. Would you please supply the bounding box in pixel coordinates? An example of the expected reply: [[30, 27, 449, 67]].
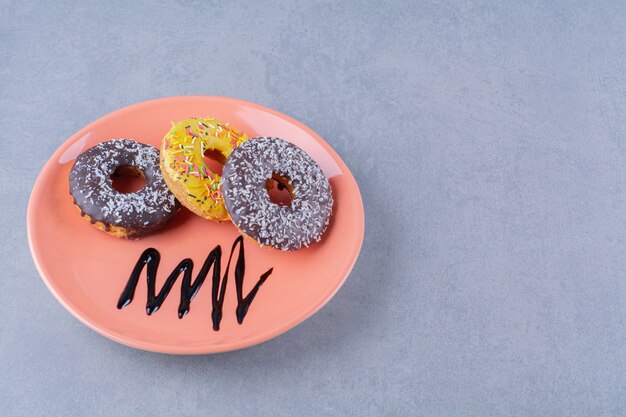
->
[[117, 236, 274, 331]]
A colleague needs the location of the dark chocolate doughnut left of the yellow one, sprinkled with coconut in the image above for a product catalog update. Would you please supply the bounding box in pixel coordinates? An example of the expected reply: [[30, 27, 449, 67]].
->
[[70, 139, 179, 238]]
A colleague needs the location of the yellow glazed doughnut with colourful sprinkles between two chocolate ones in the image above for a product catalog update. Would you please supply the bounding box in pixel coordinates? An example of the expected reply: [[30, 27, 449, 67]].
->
[[161, 117, 248, 221]]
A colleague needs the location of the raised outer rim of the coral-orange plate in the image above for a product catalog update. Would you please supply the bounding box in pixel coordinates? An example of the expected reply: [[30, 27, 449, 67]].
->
[[26, 95, 365, 355]]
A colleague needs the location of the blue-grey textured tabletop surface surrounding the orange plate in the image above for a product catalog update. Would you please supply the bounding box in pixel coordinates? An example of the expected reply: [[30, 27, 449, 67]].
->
[[0, 0, 626, 417]]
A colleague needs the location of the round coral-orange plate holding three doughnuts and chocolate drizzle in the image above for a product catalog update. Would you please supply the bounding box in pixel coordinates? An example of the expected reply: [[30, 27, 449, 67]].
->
[[28, 96, 364, 354]]
